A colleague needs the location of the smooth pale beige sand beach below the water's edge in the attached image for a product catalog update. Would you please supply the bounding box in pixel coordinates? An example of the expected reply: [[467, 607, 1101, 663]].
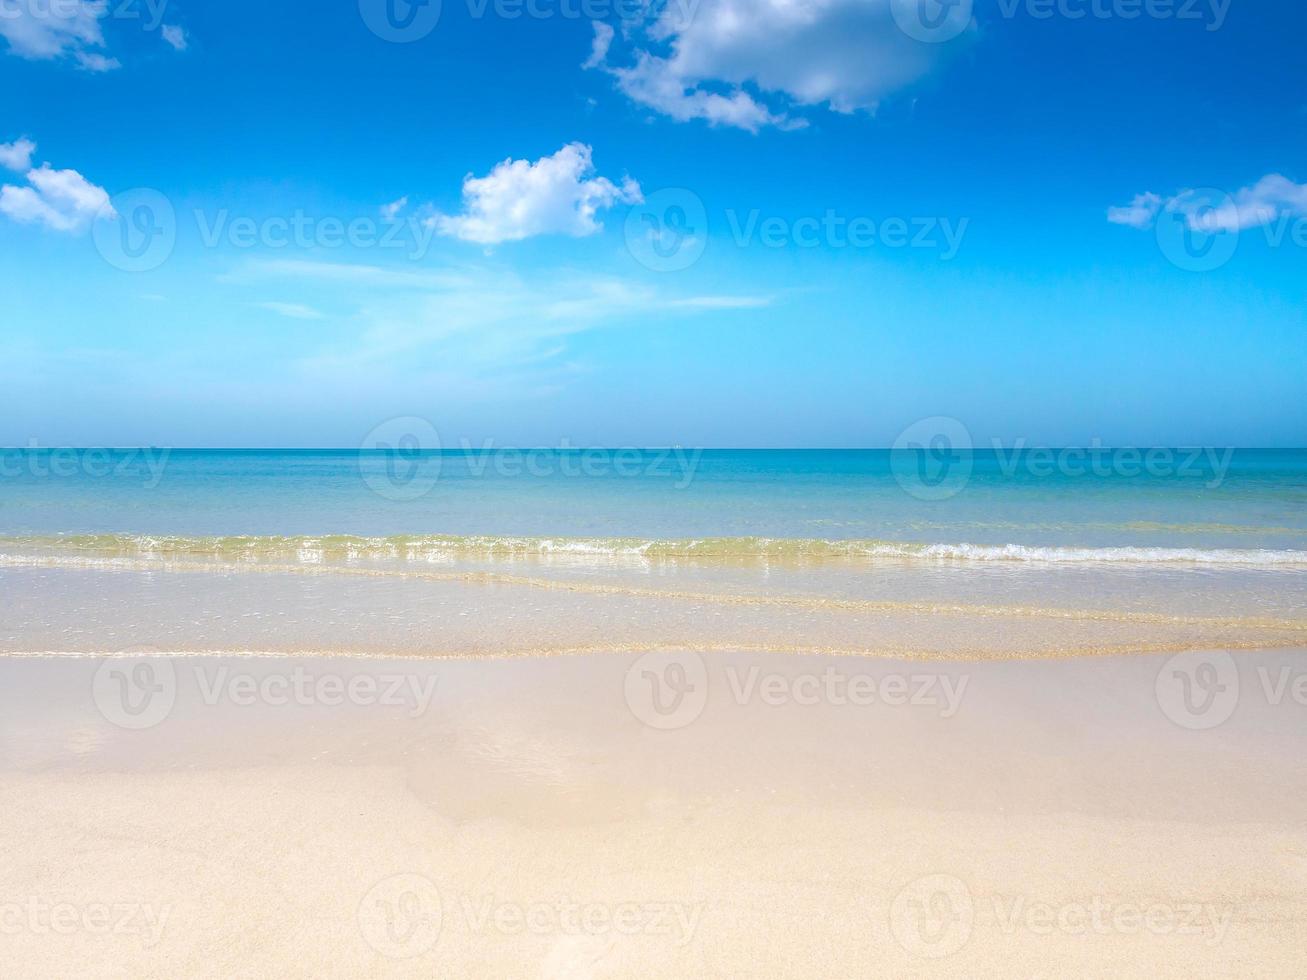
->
[[0, 649, 1307, 977]]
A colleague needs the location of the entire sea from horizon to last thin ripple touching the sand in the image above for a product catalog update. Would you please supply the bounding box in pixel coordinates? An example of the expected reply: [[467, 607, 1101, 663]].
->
[[0, 449, 1307, 659]]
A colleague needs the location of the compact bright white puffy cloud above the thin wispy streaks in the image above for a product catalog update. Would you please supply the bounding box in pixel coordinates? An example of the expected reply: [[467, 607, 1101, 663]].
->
[[431, 142, 643, 244]]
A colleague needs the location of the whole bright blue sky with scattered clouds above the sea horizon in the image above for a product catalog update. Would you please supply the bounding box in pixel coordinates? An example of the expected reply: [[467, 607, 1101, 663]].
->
[[0, 0, 1307, 447]]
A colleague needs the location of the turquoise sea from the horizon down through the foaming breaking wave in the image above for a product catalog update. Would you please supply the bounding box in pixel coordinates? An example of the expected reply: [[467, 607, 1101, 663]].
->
[[0, 448, 1307, 564]]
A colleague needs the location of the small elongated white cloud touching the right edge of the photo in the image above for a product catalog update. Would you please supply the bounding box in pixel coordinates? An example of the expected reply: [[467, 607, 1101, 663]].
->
[[1107, 174, 1307, 234]]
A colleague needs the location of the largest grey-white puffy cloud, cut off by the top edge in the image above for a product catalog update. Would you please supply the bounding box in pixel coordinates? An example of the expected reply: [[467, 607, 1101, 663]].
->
[[584, 0, 970, 132]]
